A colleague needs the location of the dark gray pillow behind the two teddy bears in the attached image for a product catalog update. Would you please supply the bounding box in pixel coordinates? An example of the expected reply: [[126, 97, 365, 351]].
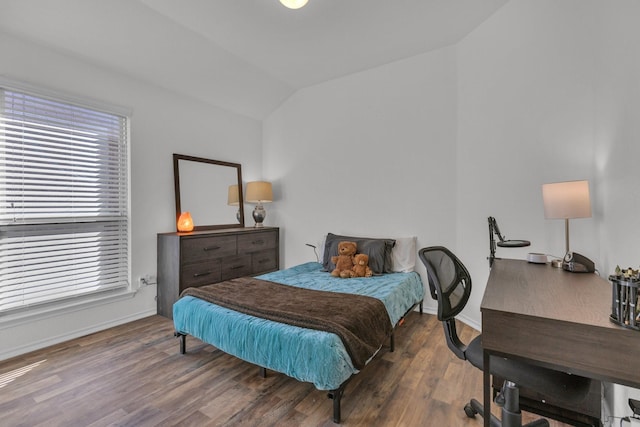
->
[[322, 233, 396, 274]]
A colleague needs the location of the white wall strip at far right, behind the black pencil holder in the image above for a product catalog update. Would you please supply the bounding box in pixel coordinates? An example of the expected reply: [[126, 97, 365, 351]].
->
[[594, 0, 640, 425]]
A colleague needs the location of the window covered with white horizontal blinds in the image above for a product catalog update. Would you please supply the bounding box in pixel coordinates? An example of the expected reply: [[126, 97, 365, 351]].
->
[[0, 81, 129, 314]]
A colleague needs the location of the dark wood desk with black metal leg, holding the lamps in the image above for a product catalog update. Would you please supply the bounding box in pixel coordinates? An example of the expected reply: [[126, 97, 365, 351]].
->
[[480, 259, 640, 426]]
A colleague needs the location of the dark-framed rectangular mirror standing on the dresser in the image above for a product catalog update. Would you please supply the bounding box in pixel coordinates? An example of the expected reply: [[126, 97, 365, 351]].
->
[[173, 154, 244, 231]]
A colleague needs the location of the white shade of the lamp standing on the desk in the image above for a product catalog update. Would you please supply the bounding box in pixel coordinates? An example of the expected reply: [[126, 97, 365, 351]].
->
[[542, 181, 591, 219]]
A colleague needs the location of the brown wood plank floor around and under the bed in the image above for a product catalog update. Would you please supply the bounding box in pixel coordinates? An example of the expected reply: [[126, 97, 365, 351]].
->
[[0, 313, 564, 427]]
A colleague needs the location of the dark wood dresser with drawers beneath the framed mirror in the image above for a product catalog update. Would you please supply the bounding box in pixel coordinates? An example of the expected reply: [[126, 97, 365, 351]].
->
[[157, 227, 280, 318]]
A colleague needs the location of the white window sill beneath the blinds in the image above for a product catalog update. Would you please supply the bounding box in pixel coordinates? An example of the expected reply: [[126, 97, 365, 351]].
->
[[0, 289, 137, 330]]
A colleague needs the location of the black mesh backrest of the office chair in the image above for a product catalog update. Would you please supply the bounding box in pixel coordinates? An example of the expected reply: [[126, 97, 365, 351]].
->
[[418, 246, 471, 360]]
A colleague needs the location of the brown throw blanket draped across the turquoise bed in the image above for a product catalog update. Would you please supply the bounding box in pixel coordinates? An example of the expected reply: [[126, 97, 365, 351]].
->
[[181, 277, 393, 369]]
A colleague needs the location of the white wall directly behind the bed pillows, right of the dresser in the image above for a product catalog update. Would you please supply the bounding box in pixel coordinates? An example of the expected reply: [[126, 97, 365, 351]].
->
[[264, 48, 457, 318]]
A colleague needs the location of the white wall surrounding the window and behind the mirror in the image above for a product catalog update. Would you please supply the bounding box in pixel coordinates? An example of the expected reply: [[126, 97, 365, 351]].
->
[[0, 34, 262, 359]]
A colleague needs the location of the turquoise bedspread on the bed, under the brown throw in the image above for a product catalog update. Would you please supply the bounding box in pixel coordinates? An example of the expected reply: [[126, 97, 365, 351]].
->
[[173, 262, 424, 390]]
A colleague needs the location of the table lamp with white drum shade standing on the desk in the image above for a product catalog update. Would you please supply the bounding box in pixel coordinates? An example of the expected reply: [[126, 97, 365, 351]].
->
[[542, 181, 594, 273]]
